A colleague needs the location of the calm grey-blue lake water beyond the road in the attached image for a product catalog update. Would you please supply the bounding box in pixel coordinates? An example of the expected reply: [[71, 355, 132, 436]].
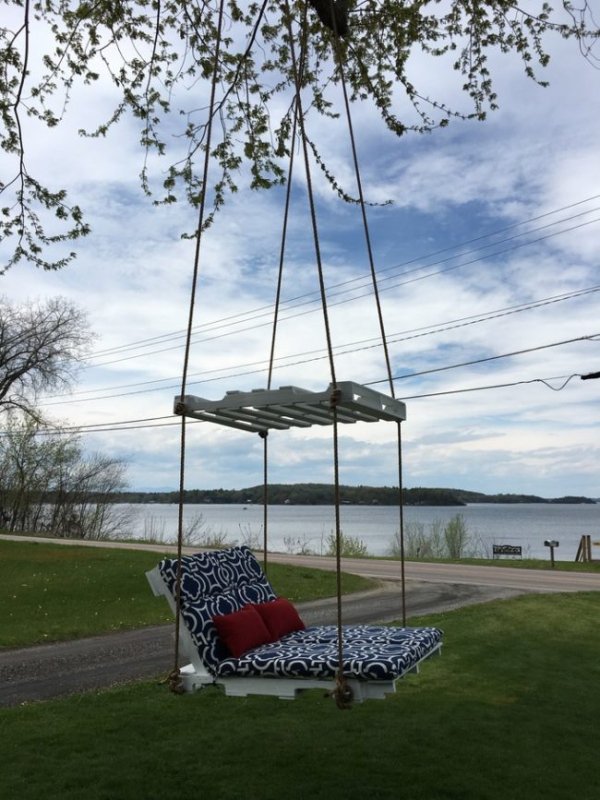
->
[[118, 503, 600, 561]]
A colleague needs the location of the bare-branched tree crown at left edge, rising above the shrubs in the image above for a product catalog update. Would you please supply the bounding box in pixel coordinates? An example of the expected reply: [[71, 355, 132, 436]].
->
[[0, 297, 91, 420]]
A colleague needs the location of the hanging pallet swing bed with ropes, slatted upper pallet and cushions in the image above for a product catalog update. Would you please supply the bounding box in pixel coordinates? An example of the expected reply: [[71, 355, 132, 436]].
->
[[147, 4, 442, 708]]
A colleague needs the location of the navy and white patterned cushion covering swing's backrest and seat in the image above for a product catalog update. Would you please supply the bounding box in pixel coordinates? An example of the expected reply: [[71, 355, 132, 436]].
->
[[159, 547, 442, 680]]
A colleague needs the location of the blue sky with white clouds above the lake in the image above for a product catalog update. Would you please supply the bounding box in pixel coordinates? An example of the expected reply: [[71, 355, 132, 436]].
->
[[0, 6, 600, 497]]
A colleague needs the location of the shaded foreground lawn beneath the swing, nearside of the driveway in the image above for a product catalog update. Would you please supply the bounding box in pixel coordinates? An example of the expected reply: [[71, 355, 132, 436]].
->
[[0, 592, 600, 800]]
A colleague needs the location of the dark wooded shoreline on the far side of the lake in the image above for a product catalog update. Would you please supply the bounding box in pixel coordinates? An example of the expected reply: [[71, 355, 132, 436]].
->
[[112, 483, 595, 506]]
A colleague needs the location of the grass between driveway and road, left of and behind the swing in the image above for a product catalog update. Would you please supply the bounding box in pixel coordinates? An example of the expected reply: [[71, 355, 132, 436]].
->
[[0, 540, 374, 647]]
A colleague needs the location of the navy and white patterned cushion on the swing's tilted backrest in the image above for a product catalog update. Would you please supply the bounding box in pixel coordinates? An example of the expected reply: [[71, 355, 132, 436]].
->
[[158, 546, 277, 672]]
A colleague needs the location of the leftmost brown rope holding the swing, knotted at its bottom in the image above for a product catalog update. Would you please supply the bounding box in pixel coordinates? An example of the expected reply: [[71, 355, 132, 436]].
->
[[168, 0, 225, 694]]
